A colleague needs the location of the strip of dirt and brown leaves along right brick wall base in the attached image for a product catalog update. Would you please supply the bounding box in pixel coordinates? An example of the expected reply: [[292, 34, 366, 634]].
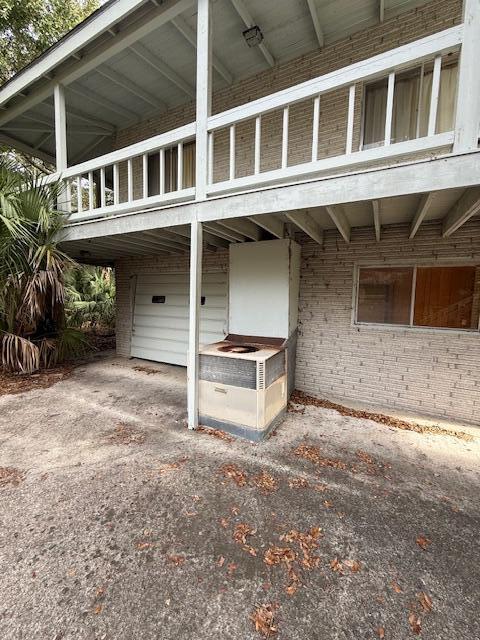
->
[[288, 391, 474, 442]]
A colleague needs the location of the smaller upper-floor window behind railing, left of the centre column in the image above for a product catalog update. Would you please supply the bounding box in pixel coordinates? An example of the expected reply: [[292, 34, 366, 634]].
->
[[148, 142, 195, 196]]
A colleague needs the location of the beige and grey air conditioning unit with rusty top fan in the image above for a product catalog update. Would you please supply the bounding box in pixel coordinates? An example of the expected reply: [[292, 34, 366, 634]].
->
[[199, 338, 287, 441]]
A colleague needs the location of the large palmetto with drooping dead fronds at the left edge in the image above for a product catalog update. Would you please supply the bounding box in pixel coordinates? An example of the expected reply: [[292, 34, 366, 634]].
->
[[0, 158, 86, 373]]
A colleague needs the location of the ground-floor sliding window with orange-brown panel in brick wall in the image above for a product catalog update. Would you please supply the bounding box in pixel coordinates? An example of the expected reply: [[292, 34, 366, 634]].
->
[[356, 266, 480, 330]]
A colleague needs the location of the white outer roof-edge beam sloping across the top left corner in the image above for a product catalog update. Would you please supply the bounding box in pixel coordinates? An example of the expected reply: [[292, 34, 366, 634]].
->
[[0, 0, 193, 126]]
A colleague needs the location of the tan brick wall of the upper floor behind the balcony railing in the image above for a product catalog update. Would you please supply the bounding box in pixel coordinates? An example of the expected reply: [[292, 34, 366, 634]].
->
[[115, 0, 462, 200]]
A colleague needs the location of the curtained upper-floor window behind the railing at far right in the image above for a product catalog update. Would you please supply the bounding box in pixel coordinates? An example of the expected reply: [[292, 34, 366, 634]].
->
[[363, 62, 458, 149]]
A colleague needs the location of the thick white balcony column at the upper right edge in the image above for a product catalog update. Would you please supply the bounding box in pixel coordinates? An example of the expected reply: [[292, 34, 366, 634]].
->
[[454, 0, 480, 153]]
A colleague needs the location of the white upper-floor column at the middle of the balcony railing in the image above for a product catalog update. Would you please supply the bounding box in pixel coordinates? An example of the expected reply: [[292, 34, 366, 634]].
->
[[196, 0, 212, 200]]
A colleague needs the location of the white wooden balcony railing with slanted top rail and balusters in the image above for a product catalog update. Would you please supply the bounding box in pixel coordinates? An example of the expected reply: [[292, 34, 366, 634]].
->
[[55, 25, 463, 221]]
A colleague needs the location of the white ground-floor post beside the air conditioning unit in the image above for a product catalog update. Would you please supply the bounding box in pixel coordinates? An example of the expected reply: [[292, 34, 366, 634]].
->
[[187, 220, 203, 429]]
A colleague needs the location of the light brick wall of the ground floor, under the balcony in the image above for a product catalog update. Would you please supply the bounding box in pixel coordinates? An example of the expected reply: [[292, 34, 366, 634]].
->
[[117, 219, 480, 423]]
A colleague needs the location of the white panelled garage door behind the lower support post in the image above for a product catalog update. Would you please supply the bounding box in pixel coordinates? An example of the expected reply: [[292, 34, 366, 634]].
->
[[131, 272, 228, 365]]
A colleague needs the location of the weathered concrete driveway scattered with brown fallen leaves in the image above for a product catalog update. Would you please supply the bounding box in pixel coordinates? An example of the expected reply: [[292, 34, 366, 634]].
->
[[0, 357, 480, 640]]
